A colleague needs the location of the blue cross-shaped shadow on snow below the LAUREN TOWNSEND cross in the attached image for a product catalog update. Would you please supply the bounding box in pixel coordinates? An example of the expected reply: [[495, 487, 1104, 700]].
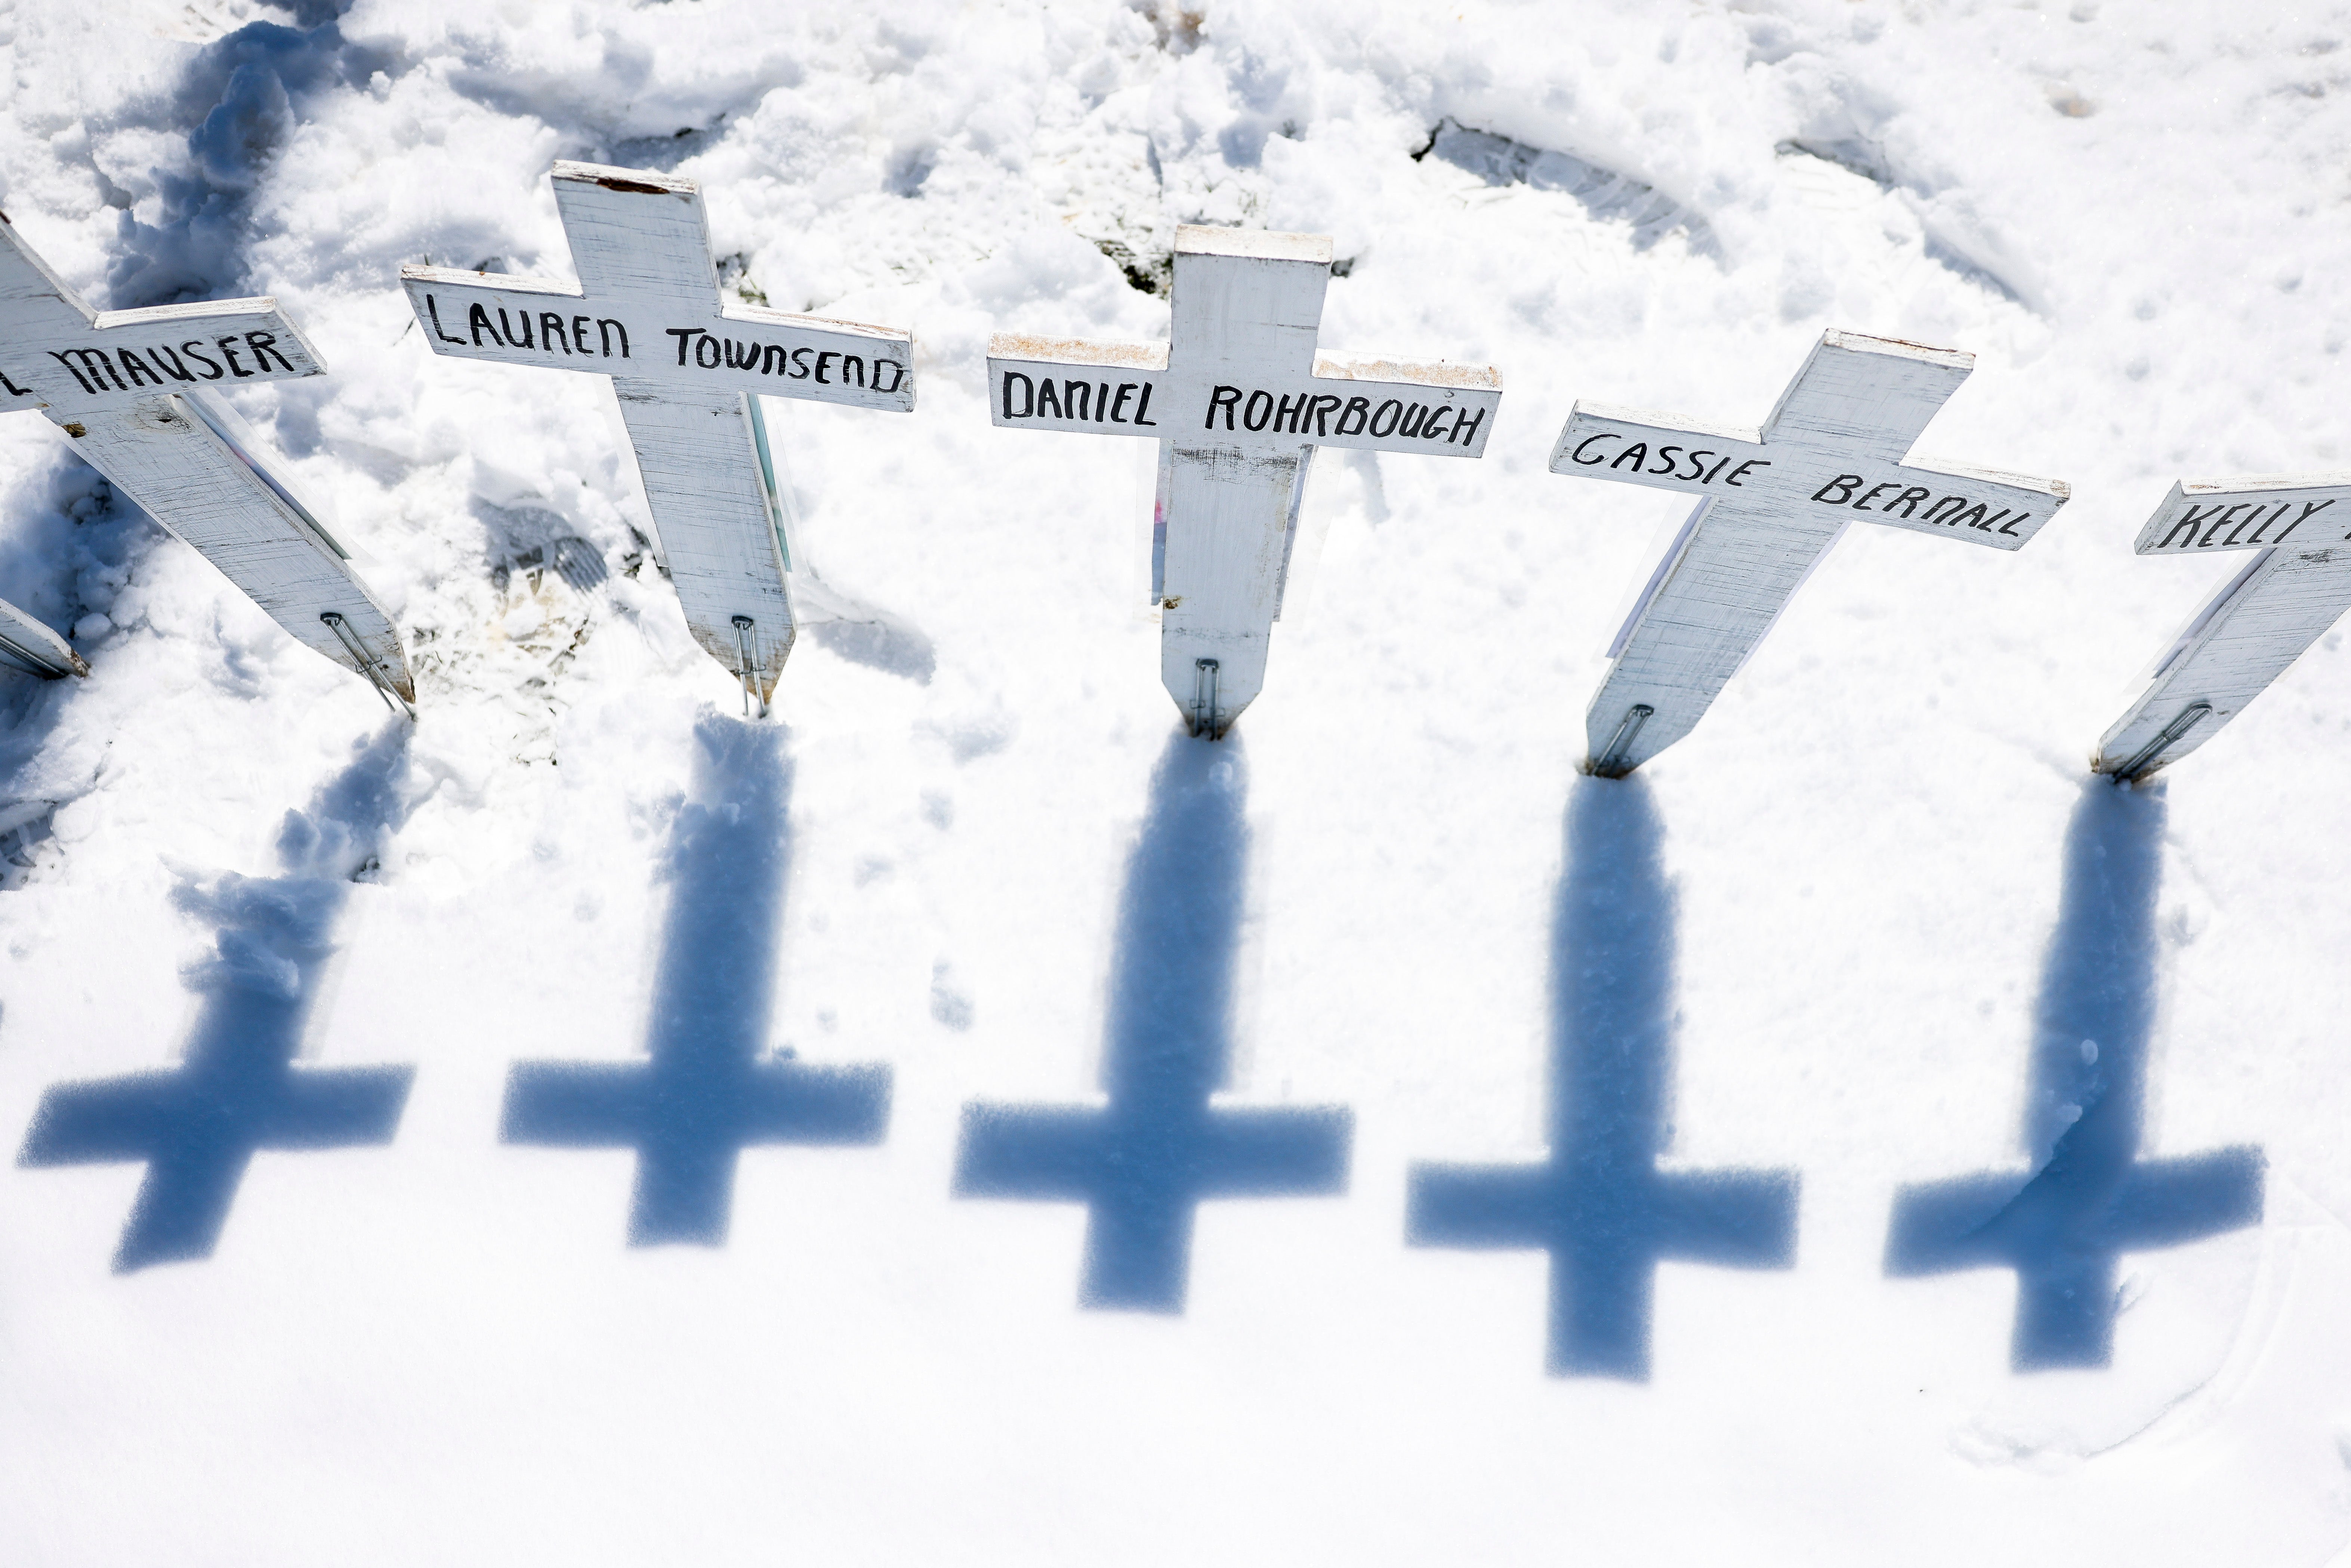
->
[[501, 712, 891, 1246]]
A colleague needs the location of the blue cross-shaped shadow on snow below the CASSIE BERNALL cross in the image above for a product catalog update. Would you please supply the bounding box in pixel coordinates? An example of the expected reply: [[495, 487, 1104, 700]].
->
[[1406, 776, 1796, 1380]]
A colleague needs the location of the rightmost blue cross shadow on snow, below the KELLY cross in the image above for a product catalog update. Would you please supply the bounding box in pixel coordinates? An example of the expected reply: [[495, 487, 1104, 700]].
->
[[1885, 778, 2264, 1371]]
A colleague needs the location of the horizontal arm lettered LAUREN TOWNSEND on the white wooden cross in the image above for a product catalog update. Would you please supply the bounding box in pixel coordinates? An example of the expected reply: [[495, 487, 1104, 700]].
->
[[399, 266, 914, 414]]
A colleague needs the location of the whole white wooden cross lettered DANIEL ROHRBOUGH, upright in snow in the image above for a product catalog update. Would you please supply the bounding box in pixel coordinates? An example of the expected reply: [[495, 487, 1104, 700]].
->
[[987, 226, 1502, 736]]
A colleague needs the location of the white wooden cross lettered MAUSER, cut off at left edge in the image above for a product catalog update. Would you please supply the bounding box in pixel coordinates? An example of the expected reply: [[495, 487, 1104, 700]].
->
[[0, 216, 416, 705]]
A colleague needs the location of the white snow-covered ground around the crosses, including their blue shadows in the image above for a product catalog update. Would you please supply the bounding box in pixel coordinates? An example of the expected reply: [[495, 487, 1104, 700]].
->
[[0, 0, 2351, 1566]]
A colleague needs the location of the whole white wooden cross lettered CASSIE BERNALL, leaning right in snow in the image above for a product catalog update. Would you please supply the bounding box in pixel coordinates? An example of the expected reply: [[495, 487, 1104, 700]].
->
[[1552, 331, 2069, 778]]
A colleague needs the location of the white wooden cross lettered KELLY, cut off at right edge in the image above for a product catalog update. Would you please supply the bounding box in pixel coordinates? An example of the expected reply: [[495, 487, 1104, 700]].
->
[[2092, 472, 2351, 778]]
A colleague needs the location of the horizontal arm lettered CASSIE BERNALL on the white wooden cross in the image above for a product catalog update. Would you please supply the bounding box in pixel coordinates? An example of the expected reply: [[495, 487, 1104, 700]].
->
[[1552, 402, 2069, 550]]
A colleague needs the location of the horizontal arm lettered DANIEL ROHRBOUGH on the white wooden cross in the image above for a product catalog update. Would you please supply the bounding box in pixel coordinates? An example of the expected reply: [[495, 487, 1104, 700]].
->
[[987, 334, 1502, 459]]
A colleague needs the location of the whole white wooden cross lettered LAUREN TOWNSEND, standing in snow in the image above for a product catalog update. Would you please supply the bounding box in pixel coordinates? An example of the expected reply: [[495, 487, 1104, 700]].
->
[[399, 162, 914, 710]]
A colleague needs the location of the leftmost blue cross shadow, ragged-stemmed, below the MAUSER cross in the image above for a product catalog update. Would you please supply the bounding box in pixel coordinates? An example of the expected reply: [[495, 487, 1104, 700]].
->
[[19, 719, 421, 1272]]
